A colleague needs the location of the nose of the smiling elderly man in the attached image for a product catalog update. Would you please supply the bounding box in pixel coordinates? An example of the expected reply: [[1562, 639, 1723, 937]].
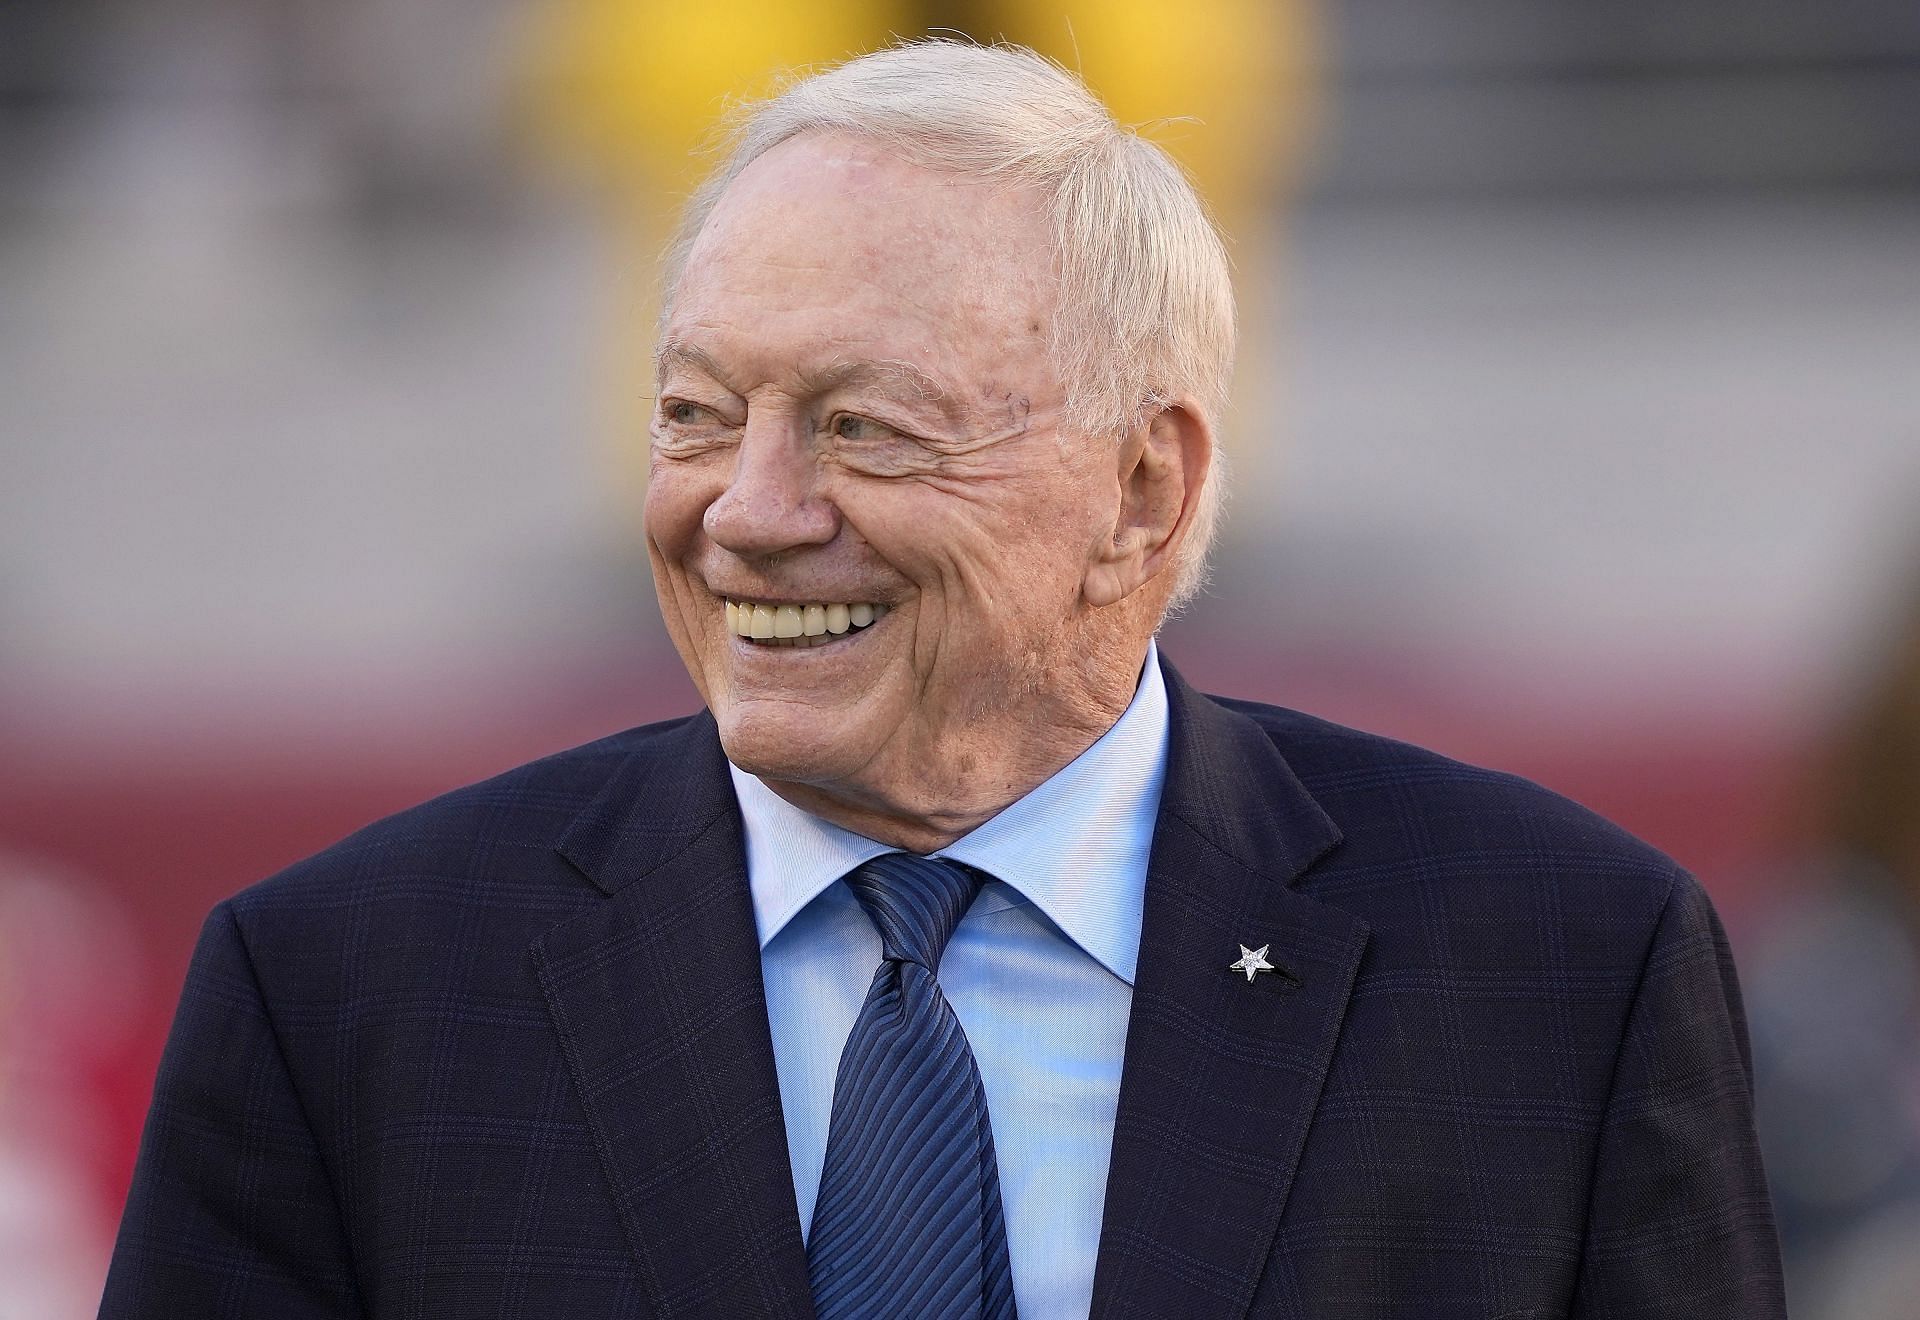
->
[[703, 418, 839, 558]]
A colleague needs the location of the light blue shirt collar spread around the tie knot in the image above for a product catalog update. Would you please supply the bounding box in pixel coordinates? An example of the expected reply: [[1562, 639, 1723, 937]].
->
[[728, 643, 1167, 986]]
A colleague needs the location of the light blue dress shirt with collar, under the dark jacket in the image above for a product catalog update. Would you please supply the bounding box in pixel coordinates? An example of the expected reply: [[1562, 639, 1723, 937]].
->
[[733, 643, 1167, 1320]]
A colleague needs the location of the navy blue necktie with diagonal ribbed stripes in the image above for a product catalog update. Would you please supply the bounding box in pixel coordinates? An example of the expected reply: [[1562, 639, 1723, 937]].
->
[[806, 852, 1014, 1320]]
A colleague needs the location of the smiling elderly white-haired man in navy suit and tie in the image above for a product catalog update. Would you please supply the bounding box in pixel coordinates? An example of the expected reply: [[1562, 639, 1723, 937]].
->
[[104, 44, 1780, 1320]]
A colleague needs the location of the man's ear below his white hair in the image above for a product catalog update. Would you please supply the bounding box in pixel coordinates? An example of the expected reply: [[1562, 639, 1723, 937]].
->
[[1083, 401, 1213, 608]]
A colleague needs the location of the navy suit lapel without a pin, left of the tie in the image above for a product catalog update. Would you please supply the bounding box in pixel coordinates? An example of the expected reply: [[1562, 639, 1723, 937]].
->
[[534, 714, 812, 1318]]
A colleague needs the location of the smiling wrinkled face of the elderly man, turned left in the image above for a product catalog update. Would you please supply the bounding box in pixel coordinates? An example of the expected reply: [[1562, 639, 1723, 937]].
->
[[647, 136, 1139, 828]]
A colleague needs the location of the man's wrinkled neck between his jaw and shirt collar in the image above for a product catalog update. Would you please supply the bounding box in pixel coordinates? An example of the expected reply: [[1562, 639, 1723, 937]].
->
[[762, 639, 1146, 854]]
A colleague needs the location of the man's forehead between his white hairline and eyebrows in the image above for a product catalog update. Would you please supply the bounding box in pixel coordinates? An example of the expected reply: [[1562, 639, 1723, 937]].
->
[[670, 134, 1058, 360]]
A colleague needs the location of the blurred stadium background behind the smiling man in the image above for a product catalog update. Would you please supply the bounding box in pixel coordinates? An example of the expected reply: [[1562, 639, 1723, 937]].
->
[[0, 0, 1920, 1320]]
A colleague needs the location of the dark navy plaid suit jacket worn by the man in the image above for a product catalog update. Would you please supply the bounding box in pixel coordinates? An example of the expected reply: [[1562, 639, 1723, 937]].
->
[[102, 670, 1784, 1320]]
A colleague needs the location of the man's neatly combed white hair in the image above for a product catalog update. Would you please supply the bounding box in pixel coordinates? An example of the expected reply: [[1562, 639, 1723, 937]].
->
[[662, 40, 1235, 608]]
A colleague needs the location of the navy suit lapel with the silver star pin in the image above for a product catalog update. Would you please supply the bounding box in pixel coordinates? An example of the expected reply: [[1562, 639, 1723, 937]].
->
[[1092, 666, 1367, 1320]]
